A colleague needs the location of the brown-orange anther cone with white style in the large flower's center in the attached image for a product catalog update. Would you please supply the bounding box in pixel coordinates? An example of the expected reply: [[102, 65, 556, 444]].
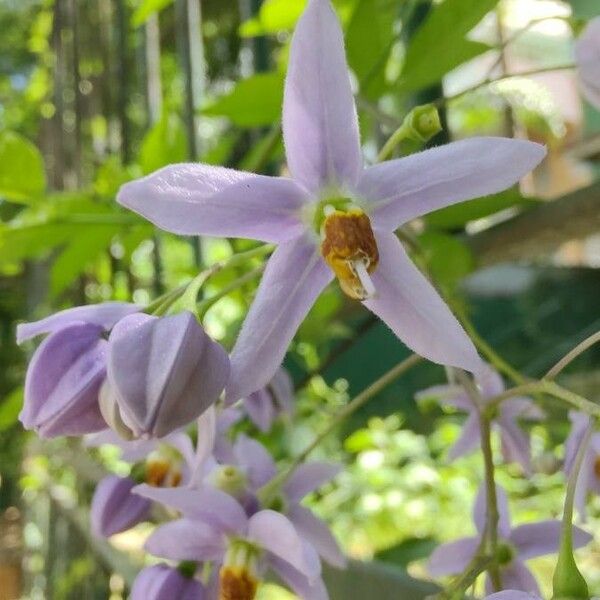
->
[[321, 205, 379, 300]]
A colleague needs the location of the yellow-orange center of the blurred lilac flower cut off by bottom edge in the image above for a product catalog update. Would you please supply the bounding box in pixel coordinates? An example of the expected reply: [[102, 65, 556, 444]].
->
[[219, 540, 258, 600]]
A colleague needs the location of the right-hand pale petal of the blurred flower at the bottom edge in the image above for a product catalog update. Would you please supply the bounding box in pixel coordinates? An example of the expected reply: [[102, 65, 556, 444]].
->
[[248, 510, 321, 579]]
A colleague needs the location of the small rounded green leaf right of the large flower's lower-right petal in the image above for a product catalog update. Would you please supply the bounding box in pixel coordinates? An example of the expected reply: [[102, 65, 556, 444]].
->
[[419, 231, 475, 289]]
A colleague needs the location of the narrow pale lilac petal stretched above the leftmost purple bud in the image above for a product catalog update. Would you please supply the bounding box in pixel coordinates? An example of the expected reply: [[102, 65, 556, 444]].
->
[[17, 302, 140, 344]]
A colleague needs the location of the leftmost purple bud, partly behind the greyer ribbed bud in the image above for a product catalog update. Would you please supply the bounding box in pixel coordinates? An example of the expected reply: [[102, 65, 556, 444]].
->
[[19, 323, 106, 437]]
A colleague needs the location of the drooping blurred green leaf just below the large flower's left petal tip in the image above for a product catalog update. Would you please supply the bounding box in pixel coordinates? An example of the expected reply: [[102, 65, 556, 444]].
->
[[50, 226, 120, 297]]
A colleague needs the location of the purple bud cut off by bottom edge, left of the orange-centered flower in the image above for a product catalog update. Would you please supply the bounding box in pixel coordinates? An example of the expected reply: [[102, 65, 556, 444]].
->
[[130, 564, 207, 600]]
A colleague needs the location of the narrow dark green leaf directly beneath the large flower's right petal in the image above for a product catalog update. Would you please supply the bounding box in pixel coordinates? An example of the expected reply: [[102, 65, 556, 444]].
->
[[425, 189, 539, 229]]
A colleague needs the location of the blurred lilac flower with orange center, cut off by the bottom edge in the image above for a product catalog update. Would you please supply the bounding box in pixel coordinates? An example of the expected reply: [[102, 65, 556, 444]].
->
[[134, 486, 327, 600]]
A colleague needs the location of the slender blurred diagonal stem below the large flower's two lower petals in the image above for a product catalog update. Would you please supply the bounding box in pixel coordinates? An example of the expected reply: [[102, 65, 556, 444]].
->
[[259, 354, 423, 505]]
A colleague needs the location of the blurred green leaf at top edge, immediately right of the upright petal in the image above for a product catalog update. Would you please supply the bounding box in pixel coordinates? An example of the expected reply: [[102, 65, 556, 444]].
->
[[346, 0, 397, 98]]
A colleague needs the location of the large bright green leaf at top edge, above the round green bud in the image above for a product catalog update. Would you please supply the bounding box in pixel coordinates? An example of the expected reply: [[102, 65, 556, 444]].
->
[[399, 0, 498, 91]]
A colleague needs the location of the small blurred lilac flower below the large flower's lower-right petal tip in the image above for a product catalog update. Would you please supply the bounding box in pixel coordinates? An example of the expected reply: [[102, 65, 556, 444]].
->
[[416, 368, 544, 473]]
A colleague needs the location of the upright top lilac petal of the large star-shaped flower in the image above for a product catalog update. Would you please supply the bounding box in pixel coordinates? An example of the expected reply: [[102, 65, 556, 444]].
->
[[283, 0, 362, 192]]
